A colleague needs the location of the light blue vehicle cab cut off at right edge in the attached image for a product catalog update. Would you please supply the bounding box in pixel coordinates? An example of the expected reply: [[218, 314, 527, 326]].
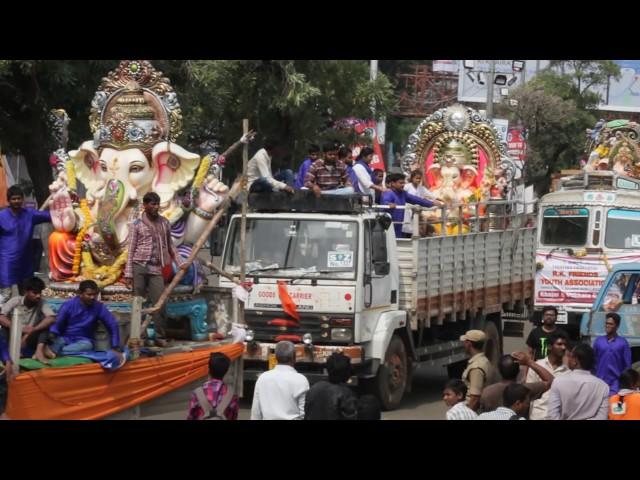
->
[[580, 263, 640, 362]]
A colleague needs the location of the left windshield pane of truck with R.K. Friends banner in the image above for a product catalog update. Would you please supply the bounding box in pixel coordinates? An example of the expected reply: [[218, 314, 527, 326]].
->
[[541, 207, 589, 246]]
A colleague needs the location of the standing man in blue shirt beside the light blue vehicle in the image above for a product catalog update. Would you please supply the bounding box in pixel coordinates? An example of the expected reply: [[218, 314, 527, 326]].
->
[[593, 313, 631, 395]]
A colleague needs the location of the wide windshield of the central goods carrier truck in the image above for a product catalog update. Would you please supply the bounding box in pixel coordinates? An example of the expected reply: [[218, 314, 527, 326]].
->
[[223, 218, 358, 279]]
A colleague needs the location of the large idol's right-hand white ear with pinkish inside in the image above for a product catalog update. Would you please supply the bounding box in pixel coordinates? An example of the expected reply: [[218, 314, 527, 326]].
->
[[152, 142, 200, 204]]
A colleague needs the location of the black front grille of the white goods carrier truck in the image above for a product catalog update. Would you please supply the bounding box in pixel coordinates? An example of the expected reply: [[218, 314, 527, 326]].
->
[[244, 311, 348, 344]]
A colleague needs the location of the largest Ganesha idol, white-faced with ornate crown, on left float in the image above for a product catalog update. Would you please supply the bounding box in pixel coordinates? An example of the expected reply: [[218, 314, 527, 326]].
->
[[49, 61, 228, 290]]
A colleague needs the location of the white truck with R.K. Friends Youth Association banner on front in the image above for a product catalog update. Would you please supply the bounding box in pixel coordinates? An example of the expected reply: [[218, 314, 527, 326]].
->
[[533, 171, 640, 338]]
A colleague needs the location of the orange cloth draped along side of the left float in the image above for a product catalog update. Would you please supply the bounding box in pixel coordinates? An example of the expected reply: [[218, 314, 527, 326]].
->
[[6, 343, 244, 420]]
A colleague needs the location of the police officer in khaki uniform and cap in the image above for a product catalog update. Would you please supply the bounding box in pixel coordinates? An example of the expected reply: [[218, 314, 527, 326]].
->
[[460, 330, 491, 411]]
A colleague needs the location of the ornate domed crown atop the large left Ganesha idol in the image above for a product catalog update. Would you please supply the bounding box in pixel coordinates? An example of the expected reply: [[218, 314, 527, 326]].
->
[[89, 60, 182, 150]]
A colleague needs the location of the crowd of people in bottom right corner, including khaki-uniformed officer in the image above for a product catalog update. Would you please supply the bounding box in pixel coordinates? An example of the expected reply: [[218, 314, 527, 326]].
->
[[443, 307, 640, 420]]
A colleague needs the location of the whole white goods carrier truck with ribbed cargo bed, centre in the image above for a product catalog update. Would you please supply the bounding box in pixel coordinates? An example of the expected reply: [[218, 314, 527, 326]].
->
[[220, 192, 536, 409]]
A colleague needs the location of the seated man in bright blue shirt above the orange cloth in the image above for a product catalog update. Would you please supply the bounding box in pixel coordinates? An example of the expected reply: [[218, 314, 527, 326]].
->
[[46, 280, 121, 358]]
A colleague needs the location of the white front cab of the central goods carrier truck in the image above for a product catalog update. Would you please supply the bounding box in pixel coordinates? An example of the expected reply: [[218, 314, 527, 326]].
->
[[220, 193, 408, 403]]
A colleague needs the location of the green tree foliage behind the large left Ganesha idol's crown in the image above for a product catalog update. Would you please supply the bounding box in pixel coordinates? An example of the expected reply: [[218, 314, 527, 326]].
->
[[0, 60, 394, 201]]
